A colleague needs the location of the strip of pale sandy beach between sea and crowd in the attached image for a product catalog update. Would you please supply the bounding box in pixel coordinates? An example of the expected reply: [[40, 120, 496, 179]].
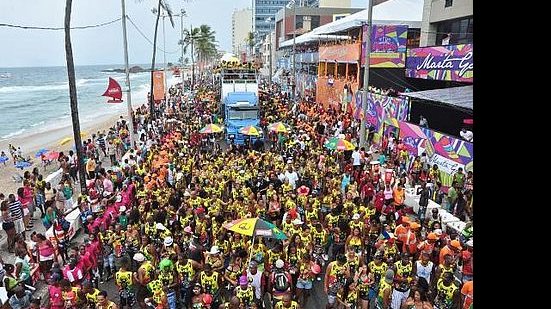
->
[[0, 115, 126, 195]]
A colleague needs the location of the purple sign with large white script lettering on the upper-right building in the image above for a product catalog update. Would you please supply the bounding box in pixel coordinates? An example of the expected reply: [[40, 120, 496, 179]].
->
[[406, 44, 473, 83]]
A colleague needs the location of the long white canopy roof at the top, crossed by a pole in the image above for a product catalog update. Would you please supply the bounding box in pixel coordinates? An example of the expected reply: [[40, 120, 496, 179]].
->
[[312, 0, 423, 34]]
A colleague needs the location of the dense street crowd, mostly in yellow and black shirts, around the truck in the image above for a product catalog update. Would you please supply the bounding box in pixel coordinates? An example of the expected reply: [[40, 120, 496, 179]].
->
[[2, 75, 473, 309]]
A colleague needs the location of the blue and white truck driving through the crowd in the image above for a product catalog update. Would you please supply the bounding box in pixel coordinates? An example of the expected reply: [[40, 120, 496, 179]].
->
[[220, 69, 264, 145]]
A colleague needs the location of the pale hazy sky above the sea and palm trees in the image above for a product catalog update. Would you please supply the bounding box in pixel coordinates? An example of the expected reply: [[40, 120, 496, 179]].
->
[[0, 0, 384, 67]]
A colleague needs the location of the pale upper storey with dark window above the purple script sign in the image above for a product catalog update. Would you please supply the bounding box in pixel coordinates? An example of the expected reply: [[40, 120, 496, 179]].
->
[[420, 0, 473, 47]]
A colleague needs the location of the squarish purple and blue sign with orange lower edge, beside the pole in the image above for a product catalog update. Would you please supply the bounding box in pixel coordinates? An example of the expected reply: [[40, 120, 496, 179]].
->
[[361, 25, 408, 68]]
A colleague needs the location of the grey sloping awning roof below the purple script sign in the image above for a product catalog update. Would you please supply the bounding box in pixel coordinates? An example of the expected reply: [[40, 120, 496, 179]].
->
[[401, 85, 473, 111]]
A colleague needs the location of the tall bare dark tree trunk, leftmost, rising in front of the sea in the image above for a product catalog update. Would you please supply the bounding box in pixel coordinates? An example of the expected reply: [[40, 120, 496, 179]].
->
[[65, 0, 86, 194]]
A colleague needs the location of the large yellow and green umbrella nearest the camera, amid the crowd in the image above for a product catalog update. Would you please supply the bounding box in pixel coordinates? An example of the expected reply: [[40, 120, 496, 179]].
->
[[223, 218, 287, 262]]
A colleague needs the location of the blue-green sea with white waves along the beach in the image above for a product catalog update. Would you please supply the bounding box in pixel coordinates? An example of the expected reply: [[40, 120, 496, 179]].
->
[[0, 65, 176, 141]]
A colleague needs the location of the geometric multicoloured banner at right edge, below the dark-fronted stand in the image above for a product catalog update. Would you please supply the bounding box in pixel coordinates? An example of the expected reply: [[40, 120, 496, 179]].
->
[[400, 121, 473, 186]]
